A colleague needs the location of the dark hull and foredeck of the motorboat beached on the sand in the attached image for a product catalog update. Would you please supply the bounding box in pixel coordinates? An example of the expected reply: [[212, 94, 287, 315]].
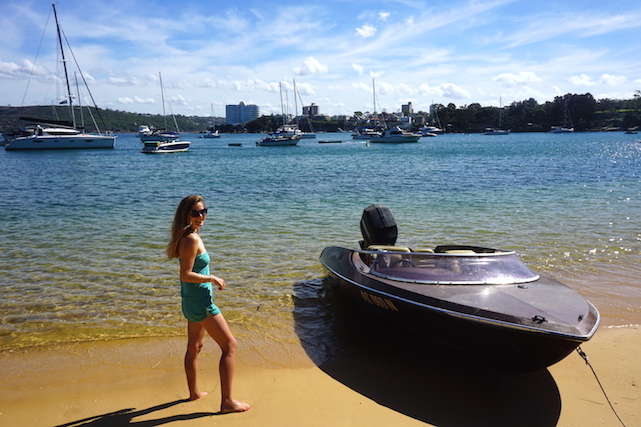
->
[[320, 247, 599, 372]]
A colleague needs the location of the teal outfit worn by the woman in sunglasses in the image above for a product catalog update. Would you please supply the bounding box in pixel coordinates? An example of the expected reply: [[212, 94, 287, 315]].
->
[[180, 252, 220, 322]]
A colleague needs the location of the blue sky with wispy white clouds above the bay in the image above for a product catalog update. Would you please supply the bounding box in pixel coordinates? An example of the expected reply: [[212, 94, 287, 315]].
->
[[0, 0, 641, 116]]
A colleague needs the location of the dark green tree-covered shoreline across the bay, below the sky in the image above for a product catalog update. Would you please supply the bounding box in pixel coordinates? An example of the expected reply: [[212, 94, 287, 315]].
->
[[0, 91, 641, 133]]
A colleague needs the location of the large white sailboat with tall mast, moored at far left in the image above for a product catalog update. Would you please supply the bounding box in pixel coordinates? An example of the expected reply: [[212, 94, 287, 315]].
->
[[5, 4, 116, 150]]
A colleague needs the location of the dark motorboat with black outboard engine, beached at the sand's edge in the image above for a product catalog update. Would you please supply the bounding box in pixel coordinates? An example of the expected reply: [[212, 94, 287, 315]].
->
[[320, 205, 600, 372]]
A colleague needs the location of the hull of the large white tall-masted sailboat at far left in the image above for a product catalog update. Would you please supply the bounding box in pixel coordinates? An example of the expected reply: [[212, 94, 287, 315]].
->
[[4, 134, 116, 151]]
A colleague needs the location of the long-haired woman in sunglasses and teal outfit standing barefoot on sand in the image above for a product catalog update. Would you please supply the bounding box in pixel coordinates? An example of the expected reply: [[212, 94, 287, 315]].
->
[[167, 195, 251, 413]]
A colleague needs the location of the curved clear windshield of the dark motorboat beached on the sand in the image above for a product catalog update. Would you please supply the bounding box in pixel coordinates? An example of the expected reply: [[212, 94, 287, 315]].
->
[[359, 251, 539, 285]]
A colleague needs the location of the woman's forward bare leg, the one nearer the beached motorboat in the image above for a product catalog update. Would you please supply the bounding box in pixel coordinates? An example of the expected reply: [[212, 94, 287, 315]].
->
[[200, 314, 251, 412]]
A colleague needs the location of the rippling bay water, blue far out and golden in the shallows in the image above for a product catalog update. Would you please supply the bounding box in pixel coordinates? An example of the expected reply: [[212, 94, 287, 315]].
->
[[0, 133, 641, 349]]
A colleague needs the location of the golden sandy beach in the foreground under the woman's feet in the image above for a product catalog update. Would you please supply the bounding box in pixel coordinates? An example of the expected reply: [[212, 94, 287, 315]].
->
[[0, 326, 641, 427]]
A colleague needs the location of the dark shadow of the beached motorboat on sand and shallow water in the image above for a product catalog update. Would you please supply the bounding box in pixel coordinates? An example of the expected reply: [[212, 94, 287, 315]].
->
[[294, 280, 561, 427]]
